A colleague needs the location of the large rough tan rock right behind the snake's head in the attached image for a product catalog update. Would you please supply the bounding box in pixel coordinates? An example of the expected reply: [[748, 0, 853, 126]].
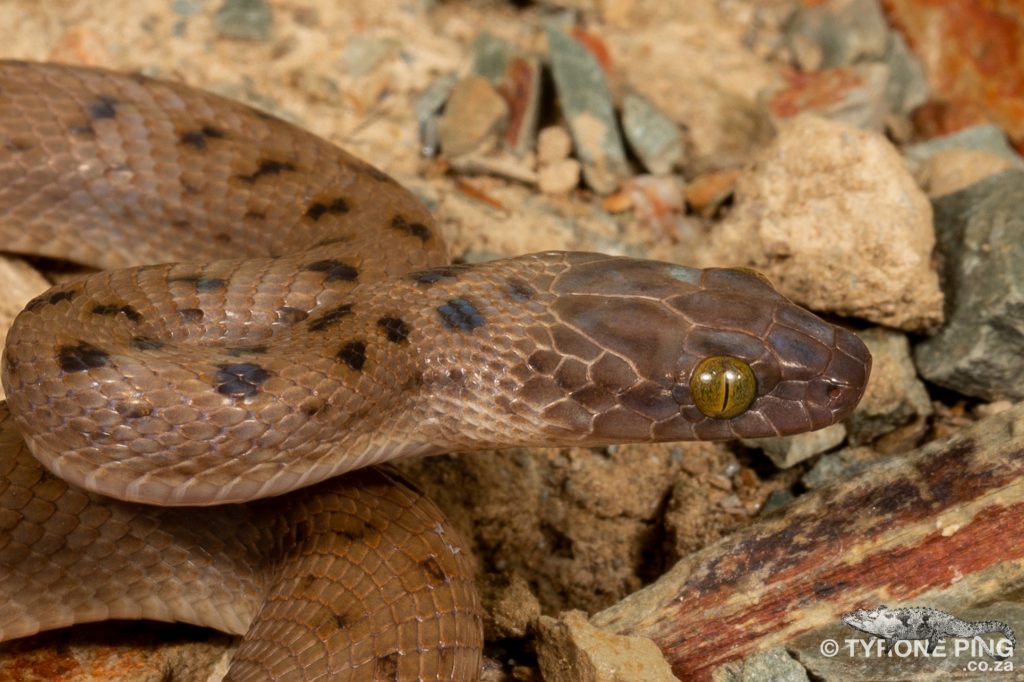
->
[[700, 116, 942, 330]]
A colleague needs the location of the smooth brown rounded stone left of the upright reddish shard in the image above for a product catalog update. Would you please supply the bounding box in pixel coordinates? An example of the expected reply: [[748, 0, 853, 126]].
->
[[438, 76, 509, 157]]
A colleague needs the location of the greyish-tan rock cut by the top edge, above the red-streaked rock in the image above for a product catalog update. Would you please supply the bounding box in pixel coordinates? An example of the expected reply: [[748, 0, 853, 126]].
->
[[783, 0, 890, 69]]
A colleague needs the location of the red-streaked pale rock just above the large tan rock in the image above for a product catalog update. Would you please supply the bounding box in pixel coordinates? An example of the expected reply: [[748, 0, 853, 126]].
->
[[763, 62, 889, 132]]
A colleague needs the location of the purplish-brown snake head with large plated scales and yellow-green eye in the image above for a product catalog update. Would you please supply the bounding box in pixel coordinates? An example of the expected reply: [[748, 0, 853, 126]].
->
[[512, 254, 871, 443]]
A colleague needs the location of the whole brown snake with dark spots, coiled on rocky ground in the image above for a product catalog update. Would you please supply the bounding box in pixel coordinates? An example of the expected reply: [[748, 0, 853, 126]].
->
[[0, 62, 870, 680]]
